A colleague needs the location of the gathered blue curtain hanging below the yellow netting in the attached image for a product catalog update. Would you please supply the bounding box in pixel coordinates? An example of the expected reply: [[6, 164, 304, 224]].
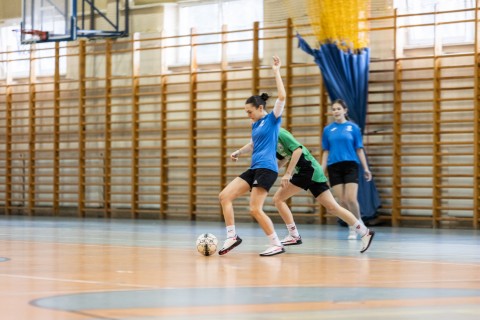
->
[[297, 34, 380, 220]]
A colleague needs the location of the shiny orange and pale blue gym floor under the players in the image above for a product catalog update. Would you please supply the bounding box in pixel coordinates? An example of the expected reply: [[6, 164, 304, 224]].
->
[[0, 216, 480, 320]]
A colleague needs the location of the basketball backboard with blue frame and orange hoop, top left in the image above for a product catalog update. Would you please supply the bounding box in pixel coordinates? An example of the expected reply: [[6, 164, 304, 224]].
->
[[20, 0, 129, 44]]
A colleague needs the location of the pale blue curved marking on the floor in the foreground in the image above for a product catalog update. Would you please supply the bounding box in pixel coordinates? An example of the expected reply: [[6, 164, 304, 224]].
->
[[31, 287, 480, 311]]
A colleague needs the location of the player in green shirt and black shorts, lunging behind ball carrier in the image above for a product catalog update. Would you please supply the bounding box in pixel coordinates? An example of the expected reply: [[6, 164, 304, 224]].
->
[[273, 128, 375, 253]]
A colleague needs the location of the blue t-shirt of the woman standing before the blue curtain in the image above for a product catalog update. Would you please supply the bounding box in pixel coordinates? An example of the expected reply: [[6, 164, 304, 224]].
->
[[322, 121, 363, 166]]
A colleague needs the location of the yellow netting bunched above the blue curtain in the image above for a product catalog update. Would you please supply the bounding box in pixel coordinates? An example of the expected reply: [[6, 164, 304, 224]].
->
[[286, 0, 370, 50]]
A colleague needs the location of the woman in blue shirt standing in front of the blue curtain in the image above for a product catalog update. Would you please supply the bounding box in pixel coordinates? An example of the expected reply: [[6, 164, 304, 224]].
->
[[322, 99, 372, 240]]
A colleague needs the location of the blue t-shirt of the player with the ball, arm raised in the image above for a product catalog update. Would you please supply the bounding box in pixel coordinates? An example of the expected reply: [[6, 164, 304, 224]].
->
[[250, 112, 282, 172]]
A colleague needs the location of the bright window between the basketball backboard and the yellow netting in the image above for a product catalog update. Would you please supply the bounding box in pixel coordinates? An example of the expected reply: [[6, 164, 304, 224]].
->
[[175, 0, 263, 64]]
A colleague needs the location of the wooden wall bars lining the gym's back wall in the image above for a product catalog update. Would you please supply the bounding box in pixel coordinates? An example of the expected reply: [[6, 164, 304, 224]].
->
[[0, 8, 480, 228]]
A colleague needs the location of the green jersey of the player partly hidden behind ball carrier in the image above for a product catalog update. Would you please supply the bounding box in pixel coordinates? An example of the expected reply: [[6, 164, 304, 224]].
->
[[277, 128, 327, 182]]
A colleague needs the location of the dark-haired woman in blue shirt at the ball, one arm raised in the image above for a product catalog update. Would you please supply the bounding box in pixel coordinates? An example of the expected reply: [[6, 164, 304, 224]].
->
[[218, 56, 286, 256]]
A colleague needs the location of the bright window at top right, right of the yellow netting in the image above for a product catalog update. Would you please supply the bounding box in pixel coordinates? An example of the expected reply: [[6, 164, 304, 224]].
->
[[396, 0, 475, 47]]
